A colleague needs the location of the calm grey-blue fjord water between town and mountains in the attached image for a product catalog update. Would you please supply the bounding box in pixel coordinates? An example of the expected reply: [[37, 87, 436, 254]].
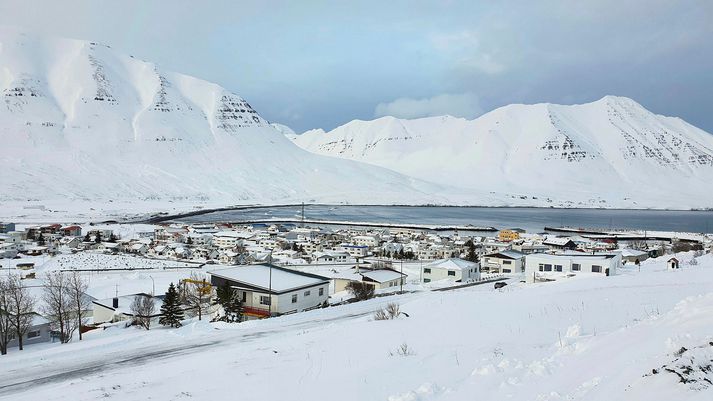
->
[[181, 205, 713, 233]]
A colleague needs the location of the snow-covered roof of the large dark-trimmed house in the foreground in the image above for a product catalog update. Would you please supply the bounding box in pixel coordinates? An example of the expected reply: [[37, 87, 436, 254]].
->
[[208, 264, 329, 293]]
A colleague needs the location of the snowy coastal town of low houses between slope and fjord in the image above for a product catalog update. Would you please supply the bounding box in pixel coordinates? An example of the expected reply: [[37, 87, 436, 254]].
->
[[0, 217, 713, 348]]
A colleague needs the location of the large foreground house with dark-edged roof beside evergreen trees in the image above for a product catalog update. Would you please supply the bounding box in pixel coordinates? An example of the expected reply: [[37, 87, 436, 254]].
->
[[208, 264, 329, 318]]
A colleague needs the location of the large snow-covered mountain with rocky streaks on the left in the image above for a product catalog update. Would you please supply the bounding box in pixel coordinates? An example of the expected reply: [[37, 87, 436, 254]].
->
[[0, 29, 468, 209]]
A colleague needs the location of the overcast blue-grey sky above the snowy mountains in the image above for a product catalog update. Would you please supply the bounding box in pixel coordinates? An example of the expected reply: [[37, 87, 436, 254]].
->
[[0, 0, 713, 133]]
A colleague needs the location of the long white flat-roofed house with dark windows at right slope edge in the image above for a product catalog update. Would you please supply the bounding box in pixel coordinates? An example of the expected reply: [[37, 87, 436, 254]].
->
[[525, 253, 621, 283]]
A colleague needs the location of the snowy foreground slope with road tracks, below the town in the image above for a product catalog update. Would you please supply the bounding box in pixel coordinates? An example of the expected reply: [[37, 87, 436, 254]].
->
[[0, 250, 713, 401]]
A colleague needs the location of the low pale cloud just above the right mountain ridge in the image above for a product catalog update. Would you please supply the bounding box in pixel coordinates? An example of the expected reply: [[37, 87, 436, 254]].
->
[[374, 93, 483, 118]]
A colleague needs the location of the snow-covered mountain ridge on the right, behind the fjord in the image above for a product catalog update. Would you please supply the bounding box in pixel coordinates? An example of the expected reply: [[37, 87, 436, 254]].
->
[[293, 96, 713, 208]]
